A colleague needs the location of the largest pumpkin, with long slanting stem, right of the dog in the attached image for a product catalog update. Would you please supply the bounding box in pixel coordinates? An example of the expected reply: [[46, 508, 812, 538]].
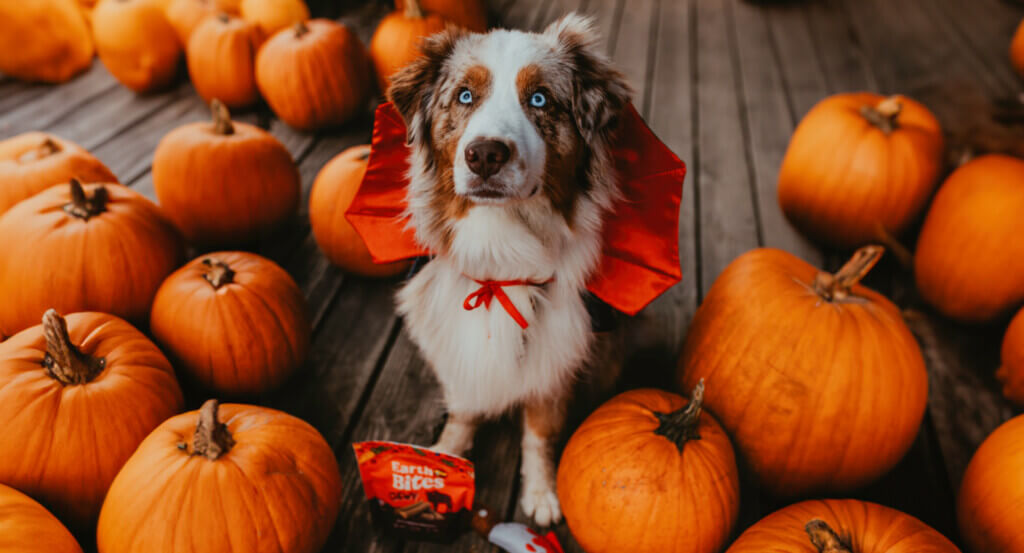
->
[[679, 246, 928, 497]]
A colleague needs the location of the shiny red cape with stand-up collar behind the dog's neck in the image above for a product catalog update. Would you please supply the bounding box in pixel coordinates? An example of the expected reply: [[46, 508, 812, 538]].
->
[[345, 102, 686, 315]]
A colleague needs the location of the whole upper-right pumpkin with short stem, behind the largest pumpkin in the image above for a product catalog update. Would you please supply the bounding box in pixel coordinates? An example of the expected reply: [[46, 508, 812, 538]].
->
[[778, 92, 943, 248]]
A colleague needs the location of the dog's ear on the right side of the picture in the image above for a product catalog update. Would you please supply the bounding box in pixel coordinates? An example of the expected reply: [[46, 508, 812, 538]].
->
[[544, 13, 632, 142]]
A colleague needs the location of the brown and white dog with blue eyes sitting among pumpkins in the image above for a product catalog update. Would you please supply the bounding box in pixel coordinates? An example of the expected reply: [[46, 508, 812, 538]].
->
[[388, 14, 630, 525]]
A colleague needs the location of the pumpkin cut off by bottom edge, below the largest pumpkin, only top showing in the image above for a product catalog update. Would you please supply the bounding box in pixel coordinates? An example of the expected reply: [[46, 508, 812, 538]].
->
[[726, 500, 959, 553]]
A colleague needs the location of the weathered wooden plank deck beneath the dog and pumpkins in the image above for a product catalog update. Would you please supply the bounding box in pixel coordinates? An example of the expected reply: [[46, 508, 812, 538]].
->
[[0, 0, 1024, 553]]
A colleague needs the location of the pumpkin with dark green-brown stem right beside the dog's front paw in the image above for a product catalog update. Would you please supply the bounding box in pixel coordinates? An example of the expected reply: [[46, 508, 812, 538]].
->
[[558, 383, 739, 553]]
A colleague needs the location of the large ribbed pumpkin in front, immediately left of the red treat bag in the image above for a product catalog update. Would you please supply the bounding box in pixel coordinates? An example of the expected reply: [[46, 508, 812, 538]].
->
[[96, 399, 341, 553]]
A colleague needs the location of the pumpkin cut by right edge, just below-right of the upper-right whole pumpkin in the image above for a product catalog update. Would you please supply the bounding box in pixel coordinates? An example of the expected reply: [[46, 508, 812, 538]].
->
[[914, 154, 1024, 323]]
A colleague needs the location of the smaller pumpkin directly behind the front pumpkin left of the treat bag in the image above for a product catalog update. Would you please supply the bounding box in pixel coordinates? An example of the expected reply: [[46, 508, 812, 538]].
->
[[150, 252, 311, 396]]
